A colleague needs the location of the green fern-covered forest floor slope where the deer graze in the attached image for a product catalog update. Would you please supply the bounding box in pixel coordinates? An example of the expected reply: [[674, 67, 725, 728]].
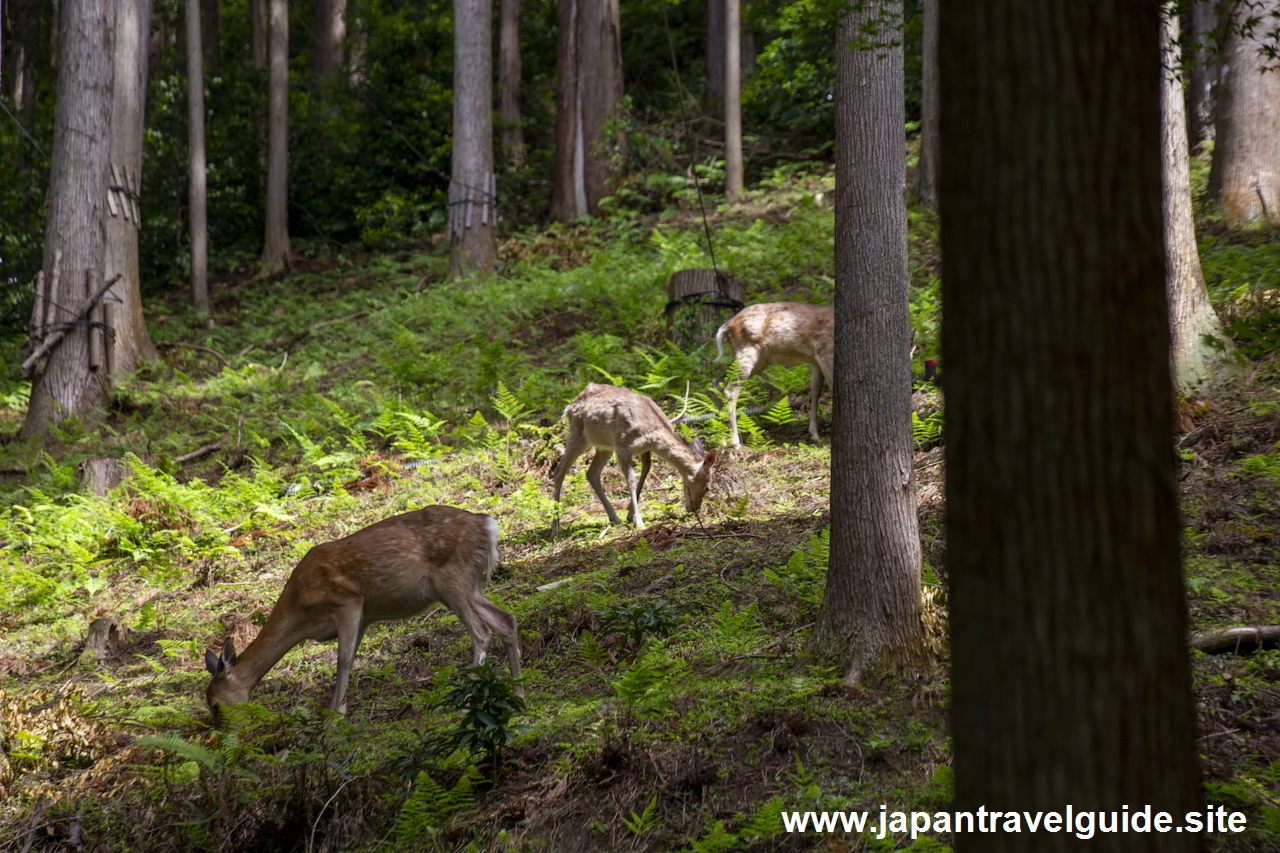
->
[[0, 157, 1280, 852]]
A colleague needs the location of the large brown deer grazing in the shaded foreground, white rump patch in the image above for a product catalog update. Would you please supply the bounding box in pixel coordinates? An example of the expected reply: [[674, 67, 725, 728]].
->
[[205, 506, 524, 724]]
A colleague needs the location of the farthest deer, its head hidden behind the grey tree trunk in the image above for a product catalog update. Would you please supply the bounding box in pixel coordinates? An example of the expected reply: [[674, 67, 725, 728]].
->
[[716, 302, 836, 447]]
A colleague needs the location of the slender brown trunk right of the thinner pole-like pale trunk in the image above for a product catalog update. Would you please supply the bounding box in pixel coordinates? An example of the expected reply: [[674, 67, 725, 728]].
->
[[262, 0, 291, 268]]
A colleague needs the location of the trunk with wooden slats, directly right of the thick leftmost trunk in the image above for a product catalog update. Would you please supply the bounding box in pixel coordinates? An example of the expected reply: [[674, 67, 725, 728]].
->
[[106, 0, 156, 373]]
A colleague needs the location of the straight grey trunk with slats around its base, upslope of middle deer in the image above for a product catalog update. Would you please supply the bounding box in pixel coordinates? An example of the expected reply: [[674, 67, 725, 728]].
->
[[449, 0, 498, 275]]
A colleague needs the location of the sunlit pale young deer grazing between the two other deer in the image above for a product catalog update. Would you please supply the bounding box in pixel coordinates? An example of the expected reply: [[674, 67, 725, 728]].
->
[[552, 383, 716, 535]]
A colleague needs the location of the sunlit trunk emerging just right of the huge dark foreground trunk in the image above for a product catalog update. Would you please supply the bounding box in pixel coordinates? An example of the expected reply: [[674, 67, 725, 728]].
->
[[1160, 14, 1224, 397]]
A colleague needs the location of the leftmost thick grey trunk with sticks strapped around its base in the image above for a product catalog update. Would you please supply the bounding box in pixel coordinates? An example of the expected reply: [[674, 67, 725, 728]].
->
[[22, 0, 115, 438]]
